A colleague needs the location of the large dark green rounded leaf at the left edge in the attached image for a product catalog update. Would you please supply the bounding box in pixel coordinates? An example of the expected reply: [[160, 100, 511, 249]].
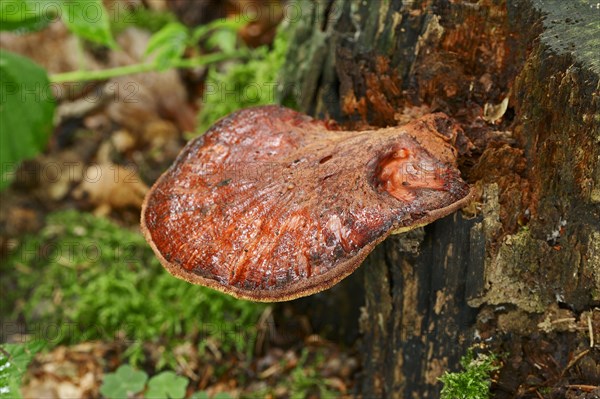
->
[[0, 50, 54, 190]]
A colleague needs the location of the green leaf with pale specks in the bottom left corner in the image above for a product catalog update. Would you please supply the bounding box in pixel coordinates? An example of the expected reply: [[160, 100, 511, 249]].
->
[[0, 341, 45, 399]]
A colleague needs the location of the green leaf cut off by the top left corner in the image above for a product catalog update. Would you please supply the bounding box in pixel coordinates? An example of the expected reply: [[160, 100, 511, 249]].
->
[[0, 0, 54, 33]]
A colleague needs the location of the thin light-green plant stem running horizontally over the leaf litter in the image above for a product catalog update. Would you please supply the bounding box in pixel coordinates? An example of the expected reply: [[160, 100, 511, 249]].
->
[[50, 50, 248, 83]]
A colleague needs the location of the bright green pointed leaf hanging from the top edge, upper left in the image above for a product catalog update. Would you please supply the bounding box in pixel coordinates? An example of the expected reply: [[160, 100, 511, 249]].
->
[[60, 0, 117, 48]]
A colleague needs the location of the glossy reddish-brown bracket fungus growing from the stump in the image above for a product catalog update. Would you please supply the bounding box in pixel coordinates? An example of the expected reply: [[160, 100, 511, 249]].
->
[[142, 106, 470, 301]]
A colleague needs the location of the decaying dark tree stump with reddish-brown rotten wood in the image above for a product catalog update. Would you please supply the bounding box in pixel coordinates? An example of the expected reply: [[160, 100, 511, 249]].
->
[[280, 0, 600, 398]]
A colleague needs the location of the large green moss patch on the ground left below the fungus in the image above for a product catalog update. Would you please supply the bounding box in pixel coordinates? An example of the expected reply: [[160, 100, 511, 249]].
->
[[0, 211, 265, 368]]
